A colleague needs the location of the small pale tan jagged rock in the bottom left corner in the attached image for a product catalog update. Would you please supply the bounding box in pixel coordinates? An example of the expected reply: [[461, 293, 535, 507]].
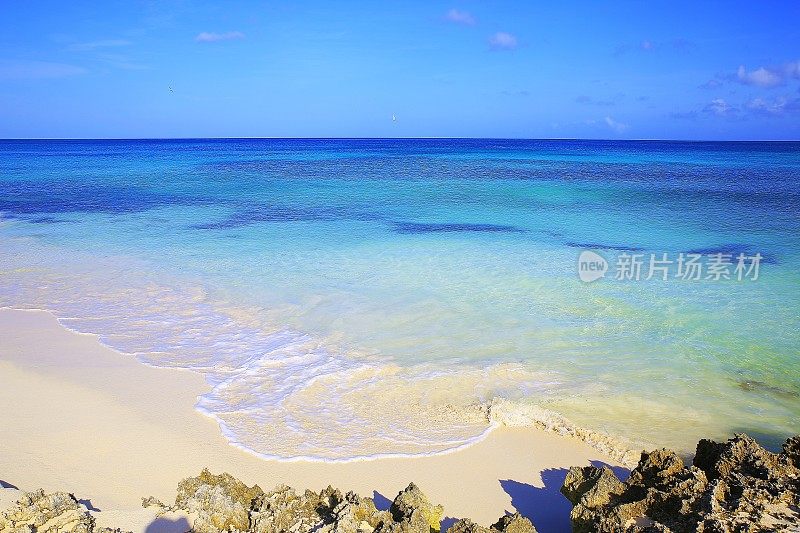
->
[[0, 489, 95, 533]]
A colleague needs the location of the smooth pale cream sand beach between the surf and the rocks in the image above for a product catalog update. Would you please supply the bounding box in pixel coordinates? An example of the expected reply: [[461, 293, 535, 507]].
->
[[0, 309, 615, 533]]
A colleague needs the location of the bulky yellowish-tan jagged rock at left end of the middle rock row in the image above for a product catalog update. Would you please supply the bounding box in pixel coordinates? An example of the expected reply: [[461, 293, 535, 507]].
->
[[173, 469, 264, 533]]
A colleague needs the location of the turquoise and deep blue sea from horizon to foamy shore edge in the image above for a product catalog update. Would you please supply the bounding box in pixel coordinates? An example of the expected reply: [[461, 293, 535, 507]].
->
[[0, 139, 800, 460]]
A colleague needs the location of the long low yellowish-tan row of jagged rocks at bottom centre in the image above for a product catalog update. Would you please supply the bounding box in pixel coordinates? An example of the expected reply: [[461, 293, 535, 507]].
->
[[142, 470, 536, 533]]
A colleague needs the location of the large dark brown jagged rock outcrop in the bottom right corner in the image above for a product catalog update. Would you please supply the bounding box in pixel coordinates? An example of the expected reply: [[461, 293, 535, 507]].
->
[[560, 435, 800, 533]]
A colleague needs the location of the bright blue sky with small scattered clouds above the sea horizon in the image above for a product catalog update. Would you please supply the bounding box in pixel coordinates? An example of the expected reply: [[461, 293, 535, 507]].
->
[[0, 0, 800, 139]]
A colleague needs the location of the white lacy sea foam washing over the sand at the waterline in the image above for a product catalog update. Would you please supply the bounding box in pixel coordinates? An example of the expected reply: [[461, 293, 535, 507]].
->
[[0, 233, 593, 461]]
